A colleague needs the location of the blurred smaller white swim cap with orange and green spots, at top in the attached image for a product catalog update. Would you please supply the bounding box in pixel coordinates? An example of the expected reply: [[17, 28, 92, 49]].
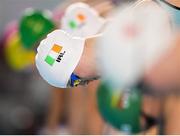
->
[[61, 2, 105, 38]]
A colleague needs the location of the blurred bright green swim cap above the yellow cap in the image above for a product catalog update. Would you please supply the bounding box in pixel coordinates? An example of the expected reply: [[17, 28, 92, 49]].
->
[[19, 9, 55, 49]]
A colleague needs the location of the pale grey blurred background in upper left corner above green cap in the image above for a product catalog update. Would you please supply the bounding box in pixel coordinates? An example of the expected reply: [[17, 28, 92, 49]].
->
[[0, 0, 61, 34]]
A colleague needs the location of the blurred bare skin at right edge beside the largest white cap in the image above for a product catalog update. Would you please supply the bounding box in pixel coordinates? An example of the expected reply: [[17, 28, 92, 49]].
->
[[145, 34, 180, 91]]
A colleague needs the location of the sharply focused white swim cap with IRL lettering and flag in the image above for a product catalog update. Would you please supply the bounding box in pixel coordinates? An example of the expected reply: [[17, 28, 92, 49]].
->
[[36, 30, 85, 88]]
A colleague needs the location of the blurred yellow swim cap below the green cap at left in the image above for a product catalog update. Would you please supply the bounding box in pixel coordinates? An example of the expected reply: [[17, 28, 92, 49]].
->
[[4, 32, 35, 71]]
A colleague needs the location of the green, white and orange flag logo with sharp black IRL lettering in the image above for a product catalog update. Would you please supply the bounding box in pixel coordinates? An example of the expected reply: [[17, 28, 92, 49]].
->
[[45, 44, 65, 66]]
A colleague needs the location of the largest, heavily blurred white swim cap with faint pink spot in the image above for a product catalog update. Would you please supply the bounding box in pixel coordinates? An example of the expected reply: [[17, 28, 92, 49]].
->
[[97, 3, 171, 89]]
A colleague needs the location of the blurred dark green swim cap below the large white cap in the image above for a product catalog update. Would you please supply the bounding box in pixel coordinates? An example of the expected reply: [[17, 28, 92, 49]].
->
[[97, 82, 141, 134]]
